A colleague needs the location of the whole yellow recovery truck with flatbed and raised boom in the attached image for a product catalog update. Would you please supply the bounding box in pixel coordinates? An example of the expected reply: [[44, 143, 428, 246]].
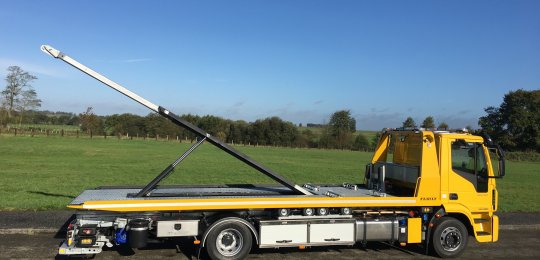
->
[[42, 45, 504, 259]]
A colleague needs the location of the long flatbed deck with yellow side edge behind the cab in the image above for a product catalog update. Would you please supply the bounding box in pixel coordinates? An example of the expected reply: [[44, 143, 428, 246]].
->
[[69, 185, 417, 212]]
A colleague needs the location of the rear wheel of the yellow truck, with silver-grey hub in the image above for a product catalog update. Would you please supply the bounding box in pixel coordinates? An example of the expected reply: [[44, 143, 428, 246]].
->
[[205, 222, 252, 260]]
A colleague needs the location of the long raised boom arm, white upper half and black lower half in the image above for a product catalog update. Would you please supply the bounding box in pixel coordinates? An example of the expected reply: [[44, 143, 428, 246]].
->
[[41, 45, 311, 195]]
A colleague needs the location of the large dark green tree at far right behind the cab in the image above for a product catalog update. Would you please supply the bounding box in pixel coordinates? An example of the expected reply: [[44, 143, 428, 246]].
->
[[478, 89, 540, 152]]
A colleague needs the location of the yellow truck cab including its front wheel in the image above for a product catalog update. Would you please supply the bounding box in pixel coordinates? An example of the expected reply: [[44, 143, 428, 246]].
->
[[365, 129, 504, 256]]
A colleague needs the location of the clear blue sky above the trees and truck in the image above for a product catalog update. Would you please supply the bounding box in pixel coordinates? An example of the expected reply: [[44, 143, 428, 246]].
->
[[0, 0, 540, 130]]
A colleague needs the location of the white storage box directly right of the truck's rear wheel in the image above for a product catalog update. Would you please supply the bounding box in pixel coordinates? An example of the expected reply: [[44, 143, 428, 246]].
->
[[259, 221, 308, 247]]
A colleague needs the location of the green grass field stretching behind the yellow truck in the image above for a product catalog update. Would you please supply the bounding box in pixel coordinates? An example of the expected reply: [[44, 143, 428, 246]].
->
[[0, 135, 540, 212]]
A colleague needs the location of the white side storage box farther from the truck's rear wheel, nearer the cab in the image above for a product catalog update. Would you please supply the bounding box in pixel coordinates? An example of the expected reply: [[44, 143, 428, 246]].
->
[[309, 223, 354, 243]]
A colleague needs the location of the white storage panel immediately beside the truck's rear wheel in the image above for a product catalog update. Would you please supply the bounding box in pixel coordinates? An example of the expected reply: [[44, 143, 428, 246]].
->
[[260, 224, 307, 246]]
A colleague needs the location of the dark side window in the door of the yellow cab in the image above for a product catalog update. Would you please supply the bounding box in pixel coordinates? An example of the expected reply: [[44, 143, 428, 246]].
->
[[452, 140, 488, 192]]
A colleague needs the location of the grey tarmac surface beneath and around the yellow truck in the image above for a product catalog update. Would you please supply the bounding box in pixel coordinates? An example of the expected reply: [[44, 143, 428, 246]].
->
[[0, 211, 540, 260]]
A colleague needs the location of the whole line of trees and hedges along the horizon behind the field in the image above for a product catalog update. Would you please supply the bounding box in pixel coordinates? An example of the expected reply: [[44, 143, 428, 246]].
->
[[0, 66, 540, 152]]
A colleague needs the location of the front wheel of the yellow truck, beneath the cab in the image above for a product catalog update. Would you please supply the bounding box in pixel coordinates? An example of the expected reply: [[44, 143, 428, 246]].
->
[[431, 217, 469, 258]]
